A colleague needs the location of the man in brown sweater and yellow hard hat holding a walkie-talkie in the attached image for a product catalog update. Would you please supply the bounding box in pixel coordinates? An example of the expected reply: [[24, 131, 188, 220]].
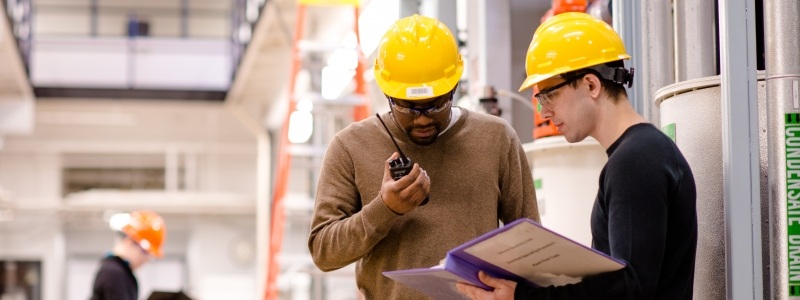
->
[[308, 15, 539, 299]]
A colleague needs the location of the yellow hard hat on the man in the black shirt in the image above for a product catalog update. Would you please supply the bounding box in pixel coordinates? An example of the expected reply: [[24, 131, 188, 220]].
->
[[519, 12, 630, 91]]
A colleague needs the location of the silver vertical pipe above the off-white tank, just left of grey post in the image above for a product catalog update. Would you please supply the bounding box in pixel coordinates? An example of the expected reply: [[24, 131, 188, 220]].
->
[[676, 0, 717, 81]]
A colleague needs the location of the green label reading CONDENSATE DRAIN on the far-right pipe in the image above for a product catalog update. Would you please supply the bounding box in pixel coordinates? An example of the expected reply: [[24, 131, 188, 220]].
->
[[784, 113, 800, 296]]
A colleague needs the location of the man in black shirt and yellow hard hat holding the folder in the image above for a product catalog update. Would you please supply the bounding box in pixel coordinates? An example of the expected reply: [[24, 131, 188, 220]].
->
[[458, 13, 697, 299]]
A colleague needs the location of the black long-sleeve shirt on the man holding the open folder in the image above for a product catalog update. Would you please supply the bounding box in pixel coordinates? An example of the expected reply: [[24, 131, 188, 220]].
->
[[515, 124, 697, 299]]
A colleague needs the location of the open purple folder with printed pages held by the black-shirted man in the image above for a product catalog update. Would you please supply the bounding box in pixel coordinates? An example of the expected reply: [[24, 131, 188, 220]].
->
[[383, 218, 625, 299]]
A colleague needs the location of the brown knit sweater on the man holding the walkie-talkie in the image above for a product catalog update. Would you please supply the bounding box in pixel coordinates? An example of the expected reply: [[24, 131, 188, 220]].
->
[[308, 109, 539, 299]]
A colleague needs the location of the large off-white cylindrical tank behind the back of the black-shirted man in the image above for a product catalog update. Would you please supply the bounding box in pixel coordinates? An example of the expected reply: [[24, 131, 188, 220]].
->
[[655, 73, 767, 300]]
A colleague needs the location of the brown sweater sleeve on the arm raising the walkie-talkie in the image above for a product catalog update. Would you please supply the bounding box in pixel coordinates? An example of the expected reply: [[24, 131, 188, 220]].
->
[[308, 137, 402, 271]]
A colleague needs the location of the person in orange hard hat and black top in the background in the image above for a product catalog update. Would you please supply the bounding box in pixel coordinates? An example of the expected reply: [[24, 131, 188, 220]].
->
[[91, 211, 167, 300]]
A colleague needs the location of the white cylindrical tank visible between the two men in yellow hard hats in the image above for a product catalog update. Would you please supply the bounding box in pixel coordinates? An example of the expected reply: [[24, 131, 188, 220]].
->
[[523, 135, 608, 246]]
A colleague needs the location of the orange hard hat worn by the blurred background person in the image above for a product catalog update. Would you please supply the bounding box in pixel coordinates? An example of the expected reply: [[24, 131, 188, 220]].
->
[[120, 211, 167, 258]]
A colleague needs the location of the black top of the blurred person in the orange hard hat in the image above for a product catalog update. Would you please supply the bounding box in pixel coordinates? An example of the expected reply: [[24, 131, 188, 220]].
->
[[91, 256, 139, 300]]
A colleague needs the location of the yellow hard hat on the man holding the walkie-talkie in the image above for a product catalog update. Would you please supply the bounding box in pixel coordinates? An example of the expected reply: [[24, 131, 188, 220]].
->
[[374, 15, 464, 101]]
